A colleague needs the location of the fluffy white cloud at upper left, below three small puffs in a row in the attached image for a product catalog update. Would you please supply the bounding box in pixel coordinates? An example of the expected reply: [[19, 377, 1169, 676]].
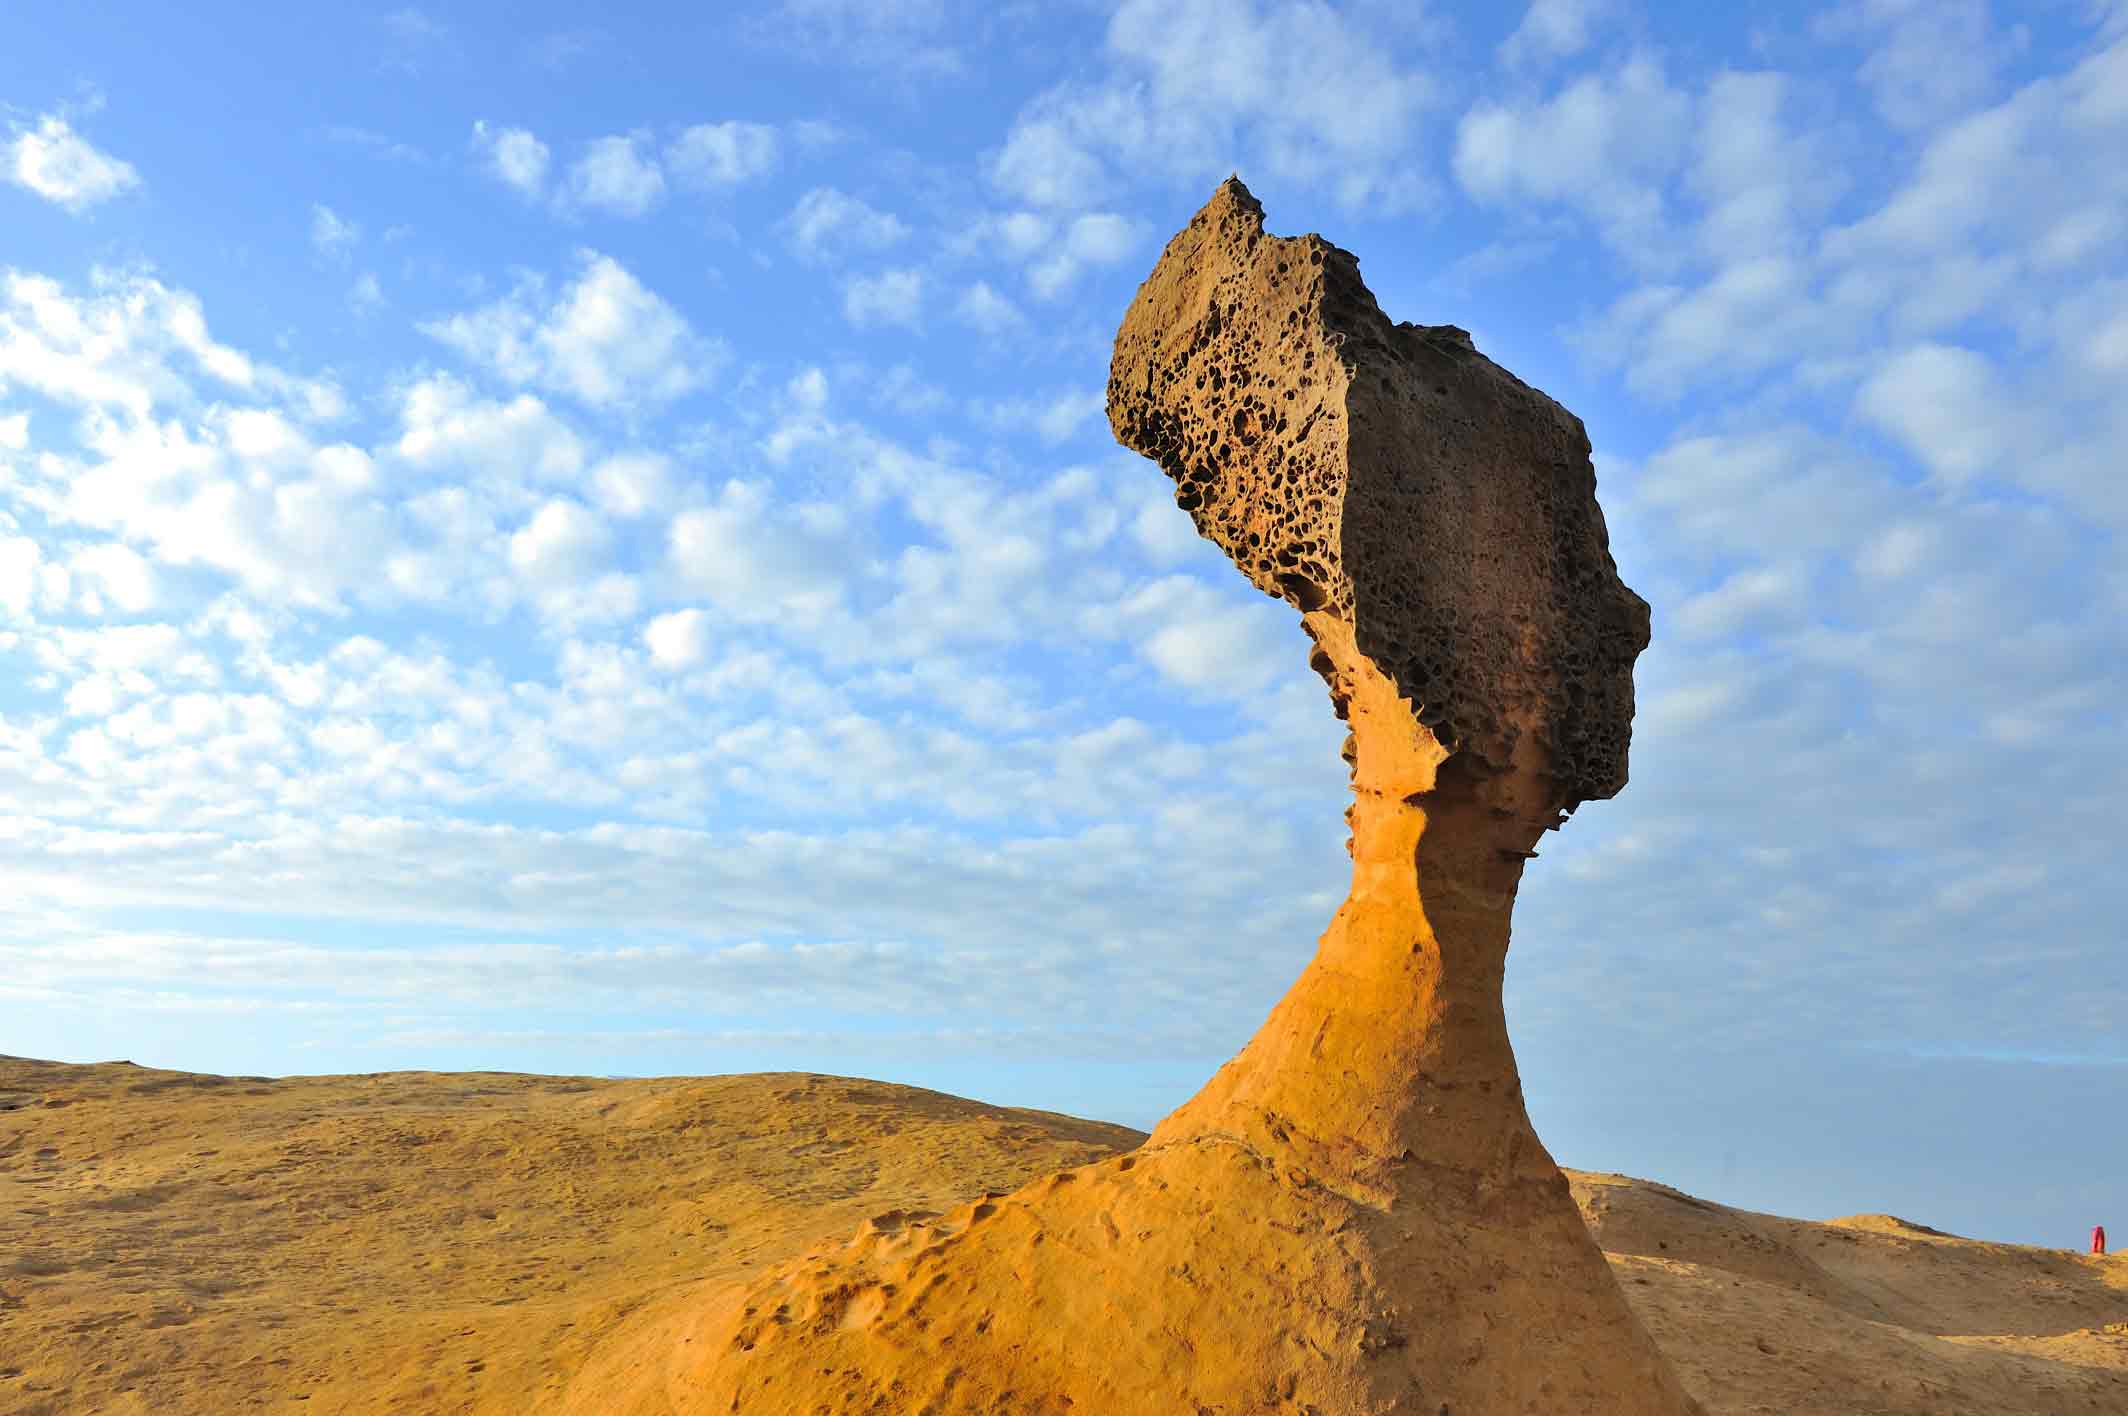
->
[[419, 251, 724, 409]]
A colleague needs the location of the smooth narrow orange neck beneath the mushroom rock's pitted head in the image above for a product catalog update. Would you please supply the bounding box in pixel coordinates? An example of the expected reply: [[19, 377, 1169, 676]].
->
[[1153, 613, 1558, 1199]]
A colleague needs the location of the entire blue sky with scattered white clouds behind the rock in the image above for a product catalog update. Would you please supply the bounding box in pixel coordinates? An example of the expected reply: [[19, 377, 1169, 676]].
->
[[0, 0, 2128, 1246]]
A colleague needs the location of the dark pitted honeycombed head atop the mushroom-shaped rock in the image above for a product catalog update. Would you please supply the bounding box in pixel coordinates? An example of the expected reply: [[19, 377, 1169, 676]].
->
[[1109, 179, 1649, 809]]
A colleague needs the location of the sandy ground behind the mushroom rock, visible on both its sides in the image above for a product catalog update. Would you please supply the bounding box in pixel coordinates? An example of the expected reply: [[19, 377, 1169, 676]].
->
[[0, 1058, 2128, 1416]]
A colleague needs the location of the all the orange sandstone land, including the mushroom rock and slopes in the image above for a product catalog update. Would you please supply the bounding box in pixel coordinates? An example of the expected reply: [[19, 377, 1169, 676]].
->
[[12, 179, 2128, 1416]]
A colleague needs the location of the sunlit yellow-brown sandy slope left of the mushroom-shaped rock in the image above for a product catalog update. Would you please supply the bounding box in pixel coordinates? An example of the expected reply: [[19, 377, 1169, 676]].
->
[[0, 1058, 1141, 1416]]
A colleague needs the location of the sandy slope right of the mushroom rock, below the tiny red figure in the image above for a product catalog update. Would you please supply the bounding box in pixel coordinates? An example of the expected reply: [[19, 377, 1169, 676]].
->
[[1568, 1173, 2128, 1416]]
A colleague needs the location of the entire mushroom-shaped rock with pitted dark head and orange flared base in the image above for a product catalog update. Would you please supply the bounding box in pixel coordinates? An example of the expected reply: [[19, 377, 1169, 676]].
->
[[689, 179, 1698, 1416]]
